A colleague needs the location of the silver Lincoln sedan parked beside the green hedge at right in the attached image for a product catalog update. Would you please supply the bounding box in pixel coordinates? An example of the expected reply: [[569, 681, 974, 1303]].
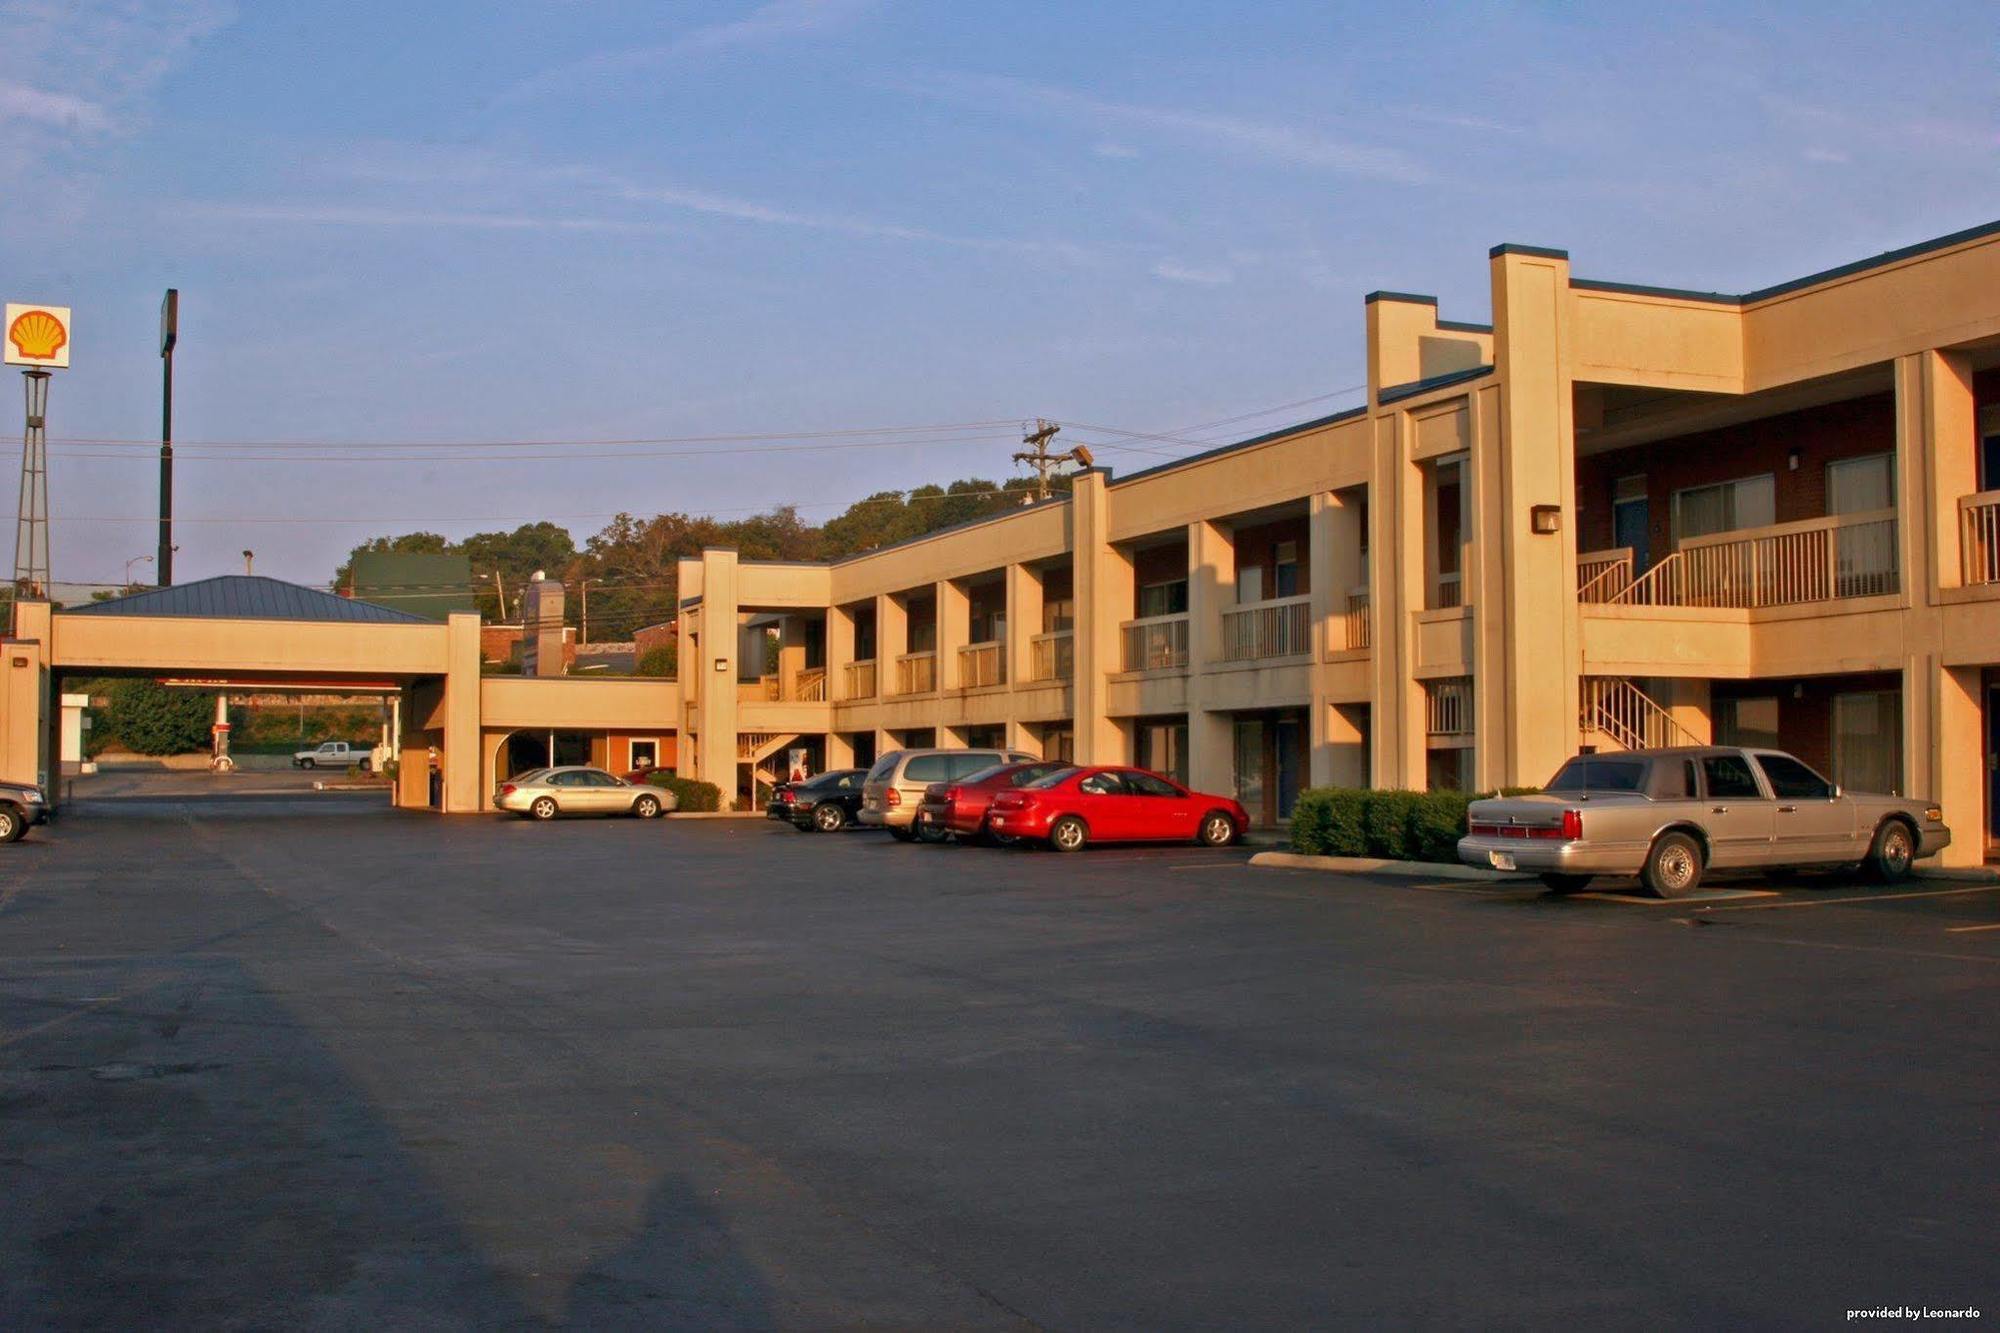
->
[[1458, 745, 1952, 899]]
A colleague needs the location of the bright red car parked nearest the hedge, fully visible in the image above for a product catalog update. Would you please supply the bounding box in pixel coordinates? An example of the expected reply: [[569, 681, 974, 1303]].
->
[[986, 769, 1250, 851]]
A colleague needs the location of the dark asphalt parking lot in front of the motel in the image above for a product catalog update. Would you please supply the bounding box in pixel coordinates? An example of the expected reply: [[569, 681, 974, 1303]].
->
[[0, 785, 2000, 1329]]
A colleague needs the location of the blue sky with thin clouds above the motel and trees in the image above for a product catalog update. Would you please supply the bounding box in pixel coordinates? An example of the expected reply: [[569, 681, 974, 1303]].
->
[[0, 0, 2000, 580]]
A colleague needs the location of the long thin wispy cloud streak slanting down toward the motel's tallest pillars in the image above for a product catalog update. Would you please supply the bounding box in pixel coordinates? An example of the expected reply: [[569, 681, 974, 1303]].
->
[[916, 74, 1432, 184]]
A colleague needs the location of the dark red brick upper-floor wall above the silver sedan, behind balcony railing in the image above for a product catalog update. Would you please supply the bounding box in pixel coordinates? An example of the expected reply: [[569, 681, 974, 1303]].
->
[[1576, 394, 1896, 560]]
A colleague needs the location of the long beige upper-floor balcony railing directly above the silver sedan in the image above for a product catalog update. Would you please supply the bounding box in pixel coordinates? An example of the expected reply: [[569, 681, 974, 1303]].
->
[[1604, 508, 1898, 608]]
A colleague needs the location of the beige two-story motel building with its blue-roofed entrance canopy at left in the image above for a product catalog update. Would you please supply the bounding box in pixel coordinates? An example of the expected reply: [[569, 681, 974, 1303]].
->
[[0, 224, 2000, 863]]
